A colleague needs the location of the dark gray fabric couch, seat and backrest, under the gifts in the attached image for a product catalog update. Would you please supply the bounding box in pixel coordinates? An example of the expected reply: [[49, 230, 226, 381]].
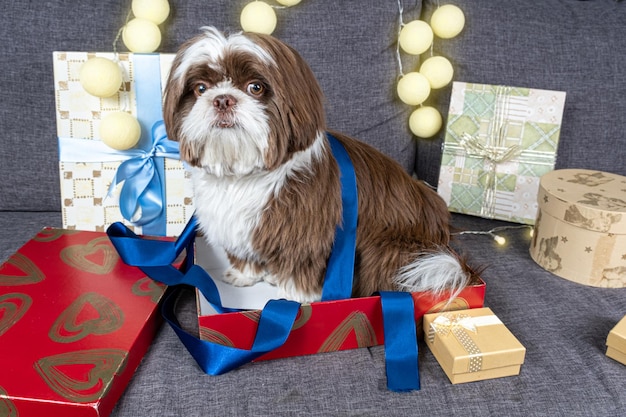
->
[[0, 0, 626, 417]]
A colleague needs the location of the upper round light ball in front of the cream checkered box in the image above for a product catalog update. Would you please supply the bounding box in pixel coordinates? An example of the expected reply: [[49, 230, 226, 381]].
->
[[78, 57, 122, 97]]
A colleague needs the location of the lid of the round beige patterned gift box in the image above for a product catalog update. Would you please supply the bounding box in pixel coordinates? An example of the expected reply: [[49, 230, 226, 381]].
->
[[538, 169, 626, 234]]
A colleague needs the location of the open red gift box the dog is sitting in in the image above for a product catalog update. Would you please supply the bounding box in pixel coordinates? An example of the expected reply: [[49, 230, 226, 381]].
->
[[196, 239, 485, 360]]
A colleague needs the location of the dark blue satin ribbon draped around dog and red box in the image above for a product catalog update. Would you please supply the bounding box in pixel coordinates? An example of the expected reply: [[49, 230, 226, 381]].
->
[[107, 135, 419, 391]]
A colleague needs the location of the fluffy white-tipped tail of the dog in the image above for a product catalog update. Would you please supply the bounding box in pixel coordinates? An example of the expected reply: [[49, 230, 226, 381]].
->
[[394, 248, 477, 301]]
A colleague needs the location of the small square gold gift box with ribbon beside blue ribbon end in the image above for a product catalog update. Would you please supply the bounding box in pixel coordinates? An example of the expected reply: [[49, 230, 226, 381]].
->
[[423, 308, 526, 384]]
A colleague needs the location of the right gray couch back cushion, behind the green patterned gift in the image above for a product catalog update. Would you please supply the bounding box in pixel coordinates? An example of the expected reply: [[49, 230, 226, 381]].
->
[[416, 0, 626, 184]]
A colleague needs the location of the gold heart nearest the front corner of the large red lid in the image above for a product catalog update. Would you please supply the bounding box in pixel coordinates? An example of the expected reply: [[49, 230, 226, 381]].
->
[[34, 349, 128, 403]]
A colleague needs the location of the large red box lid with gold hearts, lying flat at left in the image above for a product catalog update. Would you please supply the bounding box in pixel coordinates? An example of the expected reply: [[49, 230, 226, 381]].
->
[[0, 228, 165, 417]]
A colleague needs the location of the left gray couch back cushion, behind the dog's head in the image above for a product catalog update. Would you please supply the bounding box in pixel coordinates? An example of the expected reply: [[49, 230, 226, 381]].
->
[[0, 0, 421, 210]]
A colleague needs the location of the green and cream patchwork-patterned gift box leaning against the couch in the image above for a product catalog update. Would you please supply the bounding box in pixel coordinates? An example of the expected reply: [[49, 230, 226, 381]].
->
[[438, 82, 565, 224]]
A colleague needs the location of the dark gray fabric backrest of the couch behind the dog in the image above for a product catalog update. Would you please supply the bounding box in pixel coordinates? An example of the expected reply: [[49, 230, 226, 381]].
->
[[0, 0, 626, 211]]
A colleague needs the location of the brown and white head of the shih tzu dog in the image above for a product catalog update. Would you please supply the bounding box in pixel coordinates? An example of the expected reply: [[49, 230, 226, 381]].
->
[[163, 27, 324, 176]]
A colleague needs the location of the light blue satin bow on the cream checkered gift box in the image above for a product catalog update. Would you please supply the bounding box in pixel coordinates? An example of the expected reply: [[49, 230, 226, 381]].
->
[[108, 120, 180, 226]]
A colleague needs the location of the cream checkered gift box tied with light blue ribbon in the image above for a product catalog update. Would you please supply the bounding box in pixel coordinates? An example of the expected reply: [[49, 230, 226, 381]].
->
[[53, 52, 194, 236]]
